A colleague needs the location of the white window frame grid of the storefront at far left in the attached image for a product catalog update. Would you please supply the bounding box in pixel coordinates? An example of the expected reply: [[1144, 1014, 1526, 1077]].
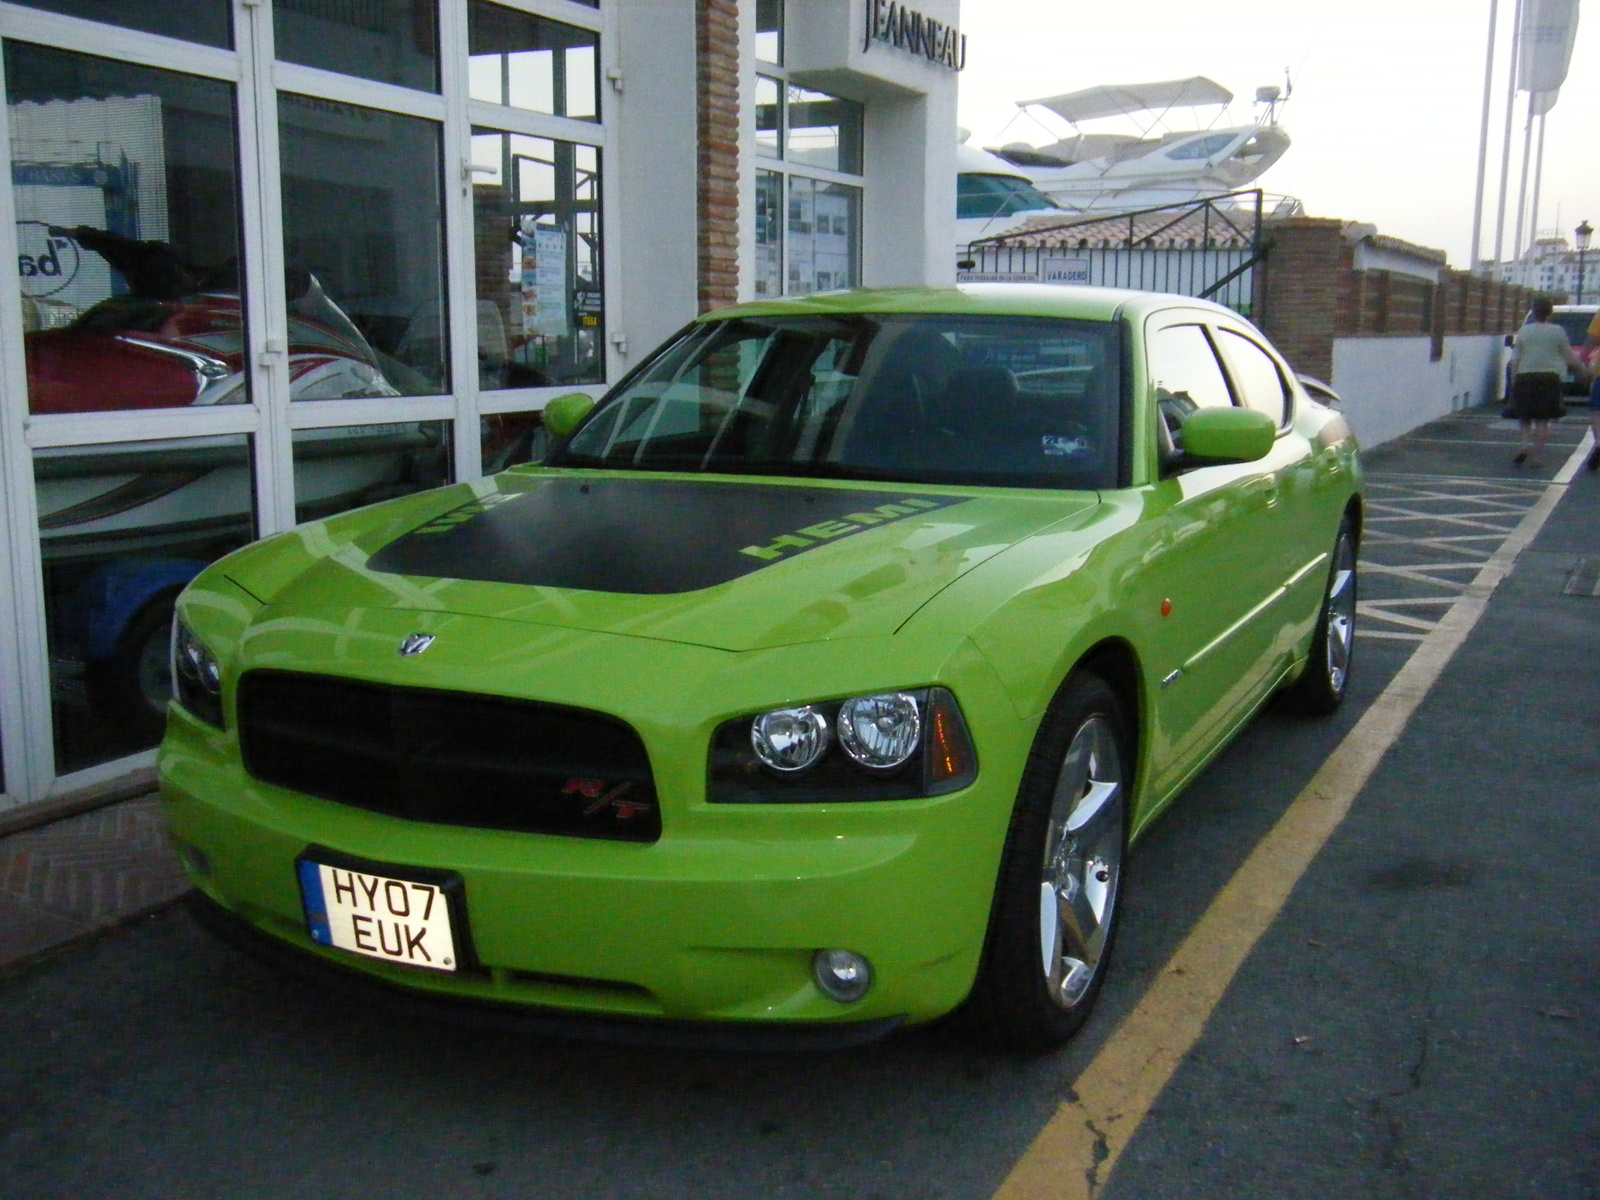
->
[[0, 0, 611, 811]]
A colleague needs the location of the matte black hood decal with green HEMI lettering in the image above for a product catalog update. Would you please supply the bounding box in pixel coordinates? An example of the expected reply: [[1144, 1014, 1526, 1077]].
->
[[368, 478, 965, 595]]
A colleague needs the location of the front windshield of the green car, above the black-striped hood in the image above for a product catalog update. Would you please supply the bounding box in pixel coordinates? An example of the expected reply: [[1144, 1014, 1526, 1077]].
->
[[549, 315, 1122, 488]]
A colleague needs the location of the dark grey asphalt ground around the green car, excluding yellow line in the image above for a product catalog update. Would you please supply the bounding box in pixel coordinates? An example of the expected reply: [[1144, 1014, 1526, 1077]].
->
[[0, 413, 1600, 1200]]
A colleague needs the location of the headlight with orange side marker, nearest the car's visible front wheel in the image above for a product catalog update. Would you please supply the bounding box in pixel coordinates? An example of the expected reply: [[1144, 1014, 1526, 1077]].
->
[[706, 688, 978, 805]]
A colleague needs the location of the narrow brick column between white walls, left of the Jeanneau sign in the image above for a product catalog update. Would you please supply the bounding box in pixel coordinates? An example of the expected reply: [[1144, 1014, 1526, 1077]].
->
[[694, 0, 739, 312]]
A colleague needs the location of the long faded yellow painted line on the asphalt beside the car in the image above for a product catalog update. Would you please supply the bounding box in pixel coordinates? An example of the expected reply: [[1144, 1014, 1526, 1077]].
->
[[995, 437, 1590, 1200]]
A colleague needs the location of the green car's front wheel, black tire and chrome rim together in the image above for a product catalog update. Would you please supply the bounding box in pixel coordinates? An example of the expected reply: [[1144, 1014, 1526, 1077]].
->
[[966, 672, 1134, 1051]]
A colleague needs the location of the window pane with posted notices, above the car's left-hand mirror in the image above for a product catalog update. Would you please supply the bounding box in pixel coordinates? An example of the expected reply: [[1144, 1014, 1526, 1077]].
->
[[472, 130, 605, 389]]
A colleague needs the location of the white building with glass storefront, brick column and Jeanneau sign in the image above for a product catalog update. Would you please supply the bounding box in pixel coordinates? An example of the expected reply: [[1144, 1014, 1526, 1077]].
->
[[0, 0, 965, 808]]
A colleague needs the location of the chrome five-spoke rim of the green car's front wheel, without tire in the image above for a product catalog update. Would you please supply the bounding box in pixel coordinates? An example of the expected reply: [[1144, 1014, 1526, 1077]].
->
[[1038, 714, 1125, 1008]]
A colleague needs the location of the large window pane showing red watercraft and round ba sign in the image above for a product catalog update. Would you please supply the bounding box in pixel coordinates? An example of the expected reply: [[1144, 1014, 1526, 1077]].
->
[[5, 42, 250, 413]]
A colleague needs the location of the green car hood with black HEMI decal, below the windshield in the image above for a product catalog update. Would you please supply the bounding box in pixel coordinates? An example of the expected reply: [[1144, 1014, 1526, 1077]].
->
[[222, 470, 1099, 651]]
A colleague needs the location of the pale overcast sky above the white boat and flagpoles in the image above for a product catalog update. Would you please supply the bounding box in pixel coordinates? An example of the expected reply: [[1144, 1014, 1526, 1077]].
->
[[960, 0, 1600, 269]]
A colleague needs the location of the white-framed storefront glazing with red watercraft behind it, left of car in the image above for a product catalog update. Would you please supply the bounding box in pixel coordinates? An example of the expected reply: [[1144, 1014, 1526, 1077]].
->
[[0, 0, 610, 806]]
